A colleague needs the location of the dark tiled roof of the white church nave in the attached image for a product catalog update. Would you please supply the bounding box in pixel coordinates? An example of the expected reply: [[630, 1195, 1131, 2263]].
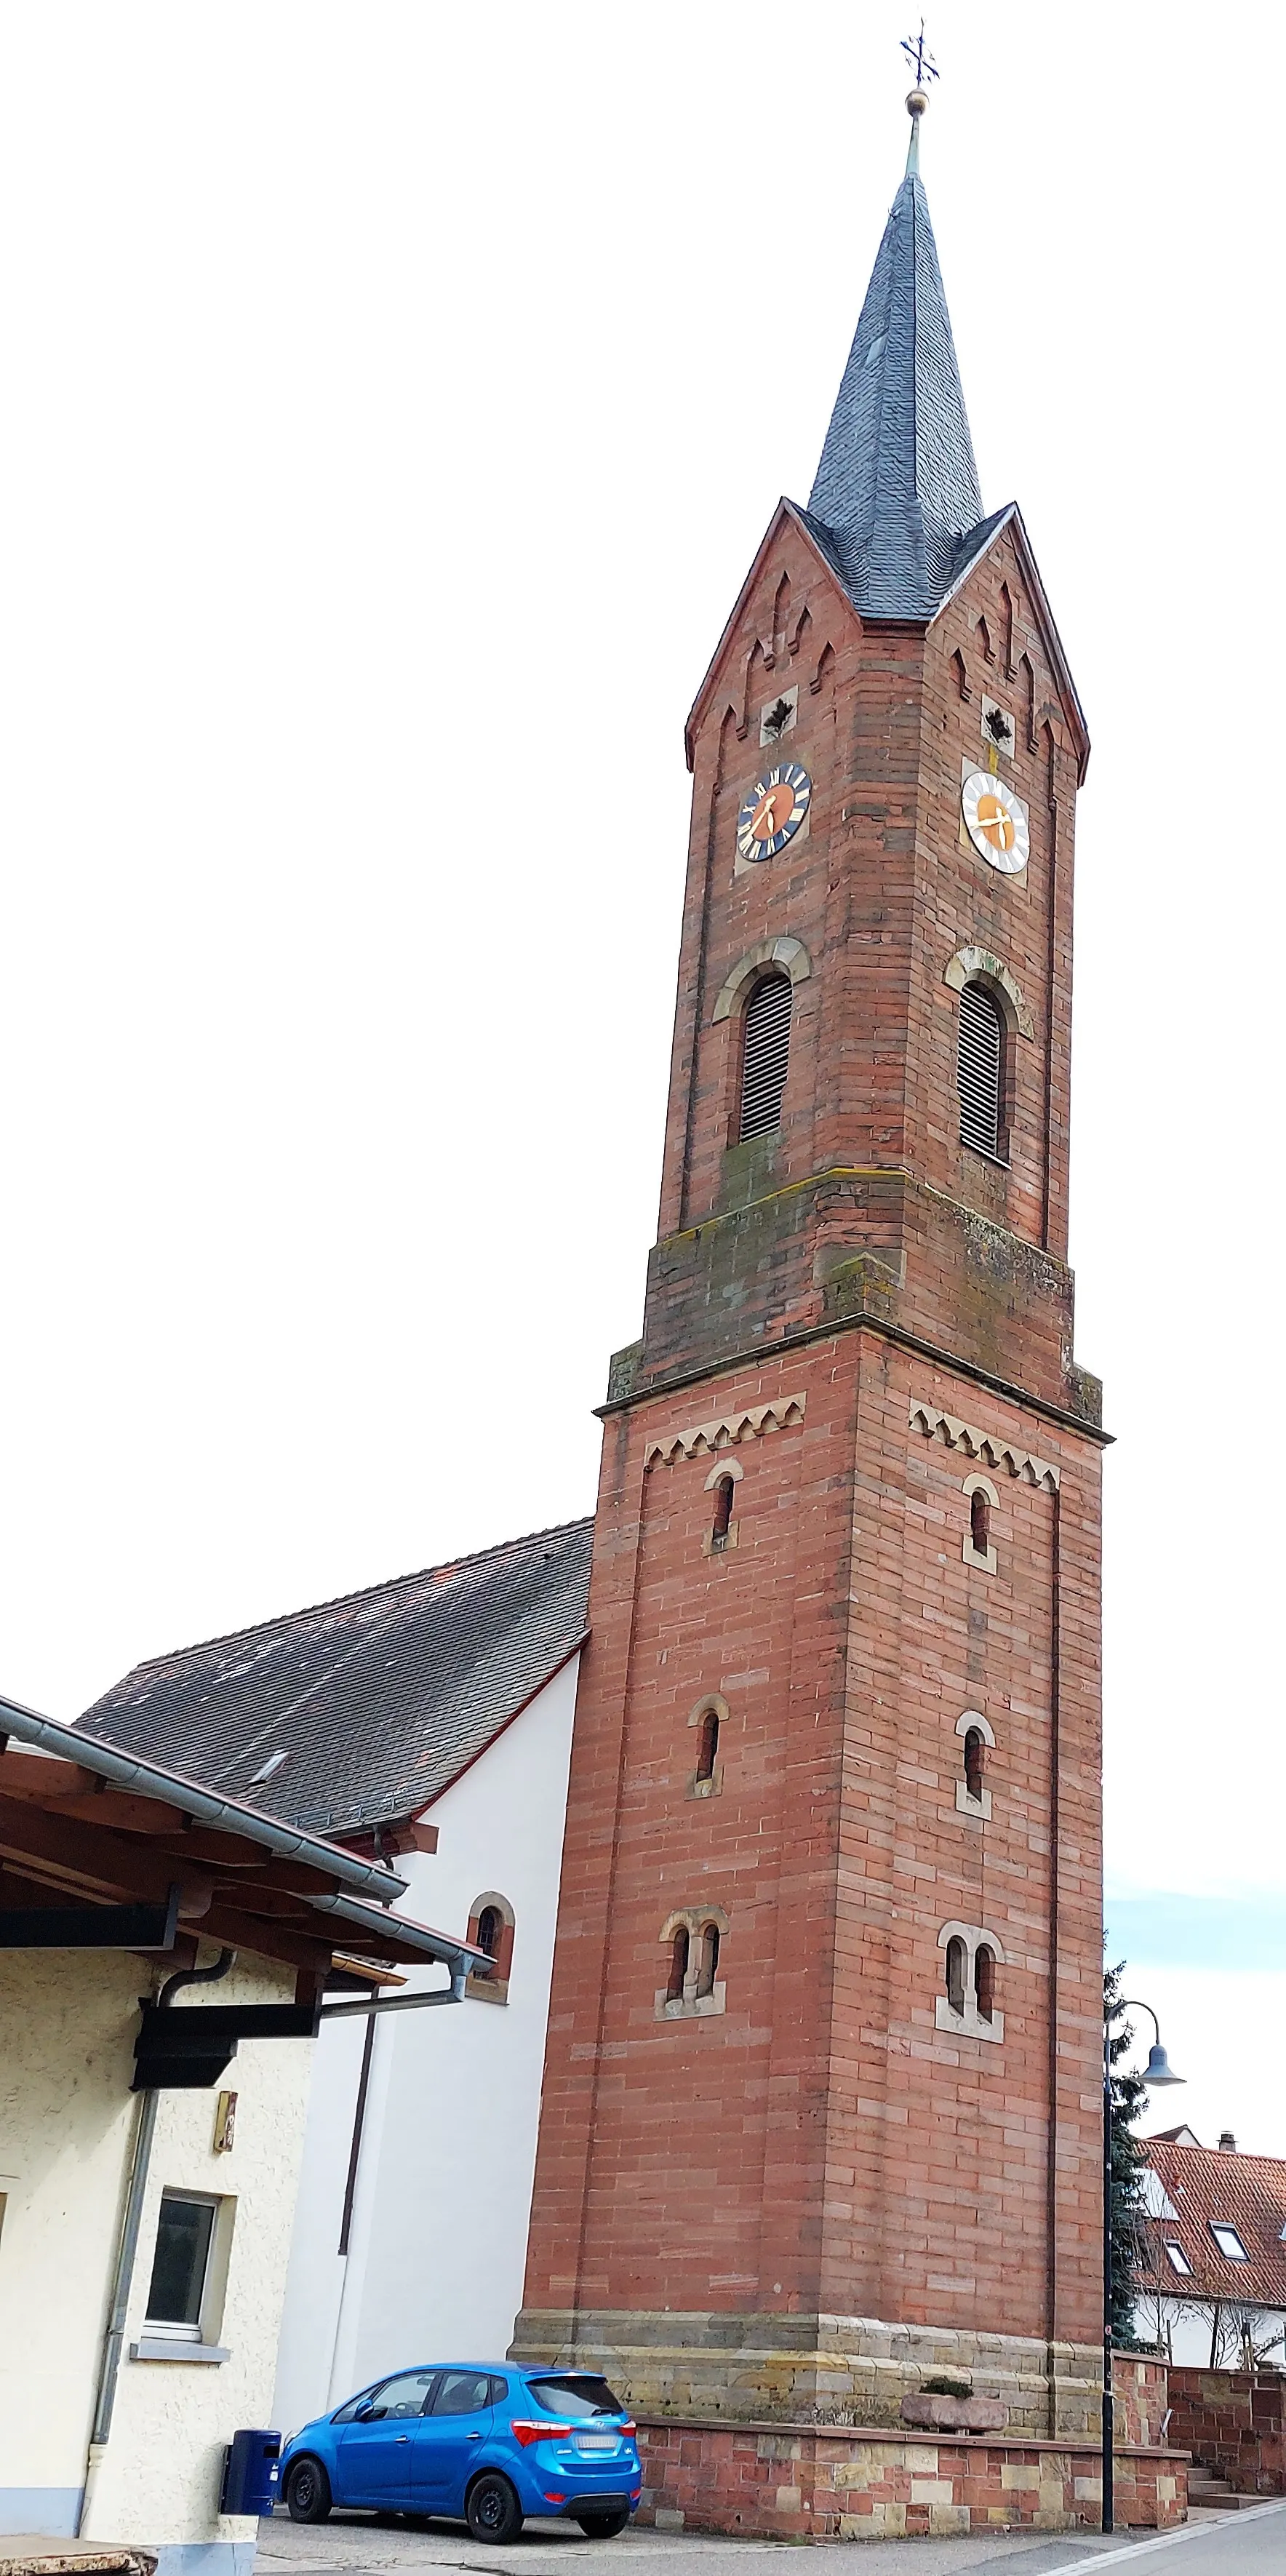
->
[[80, 1520, 593, 1832]]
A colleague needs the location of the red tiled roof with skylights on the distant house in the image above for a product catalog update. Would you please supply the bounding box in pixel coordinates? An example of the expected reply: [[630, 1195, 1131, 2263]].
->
[[1139, 2138, 1286, 2308]]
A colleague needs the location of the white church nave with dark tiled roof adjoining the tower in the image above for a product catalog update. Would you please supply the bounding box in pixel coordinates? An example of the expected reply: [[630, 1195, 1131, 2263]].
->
[[82, 1520, 593, 2429]]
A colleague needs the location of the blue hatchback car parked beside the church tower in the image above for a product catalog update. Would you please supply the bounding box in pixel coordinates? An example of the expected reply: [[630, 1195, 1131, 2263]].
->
[[279, 2362, 642, 2540]]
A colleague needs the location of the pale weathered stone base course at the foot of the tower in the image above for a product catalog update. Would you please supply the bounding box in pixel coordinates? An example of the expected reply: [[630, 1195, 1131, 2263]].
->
[[511, 2308, 1103, 2442]]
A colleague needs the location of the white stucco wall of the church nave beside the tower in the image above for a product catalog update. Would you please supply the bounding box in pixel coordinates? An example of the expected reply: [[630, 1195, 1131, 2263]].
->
[[273, 1662, 578, 2429]]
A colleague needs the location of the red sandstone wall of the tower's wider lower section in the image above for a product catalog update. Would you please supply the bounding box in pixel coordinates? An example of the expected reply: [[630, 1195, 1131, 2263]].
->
[[526, 1329, 1101, 2401]]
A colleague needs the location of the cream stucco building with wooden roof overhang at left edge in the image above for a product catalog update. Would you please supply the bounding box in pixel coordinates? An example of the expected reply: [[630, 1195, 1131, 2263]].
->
[[0, 1703, 484, 2576]]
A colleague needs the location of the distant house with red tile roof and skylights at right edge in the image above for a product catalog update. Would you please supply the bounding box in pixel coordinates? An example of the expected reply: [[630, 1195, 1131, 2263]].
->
[[1134, 2128, 1286, 2370]]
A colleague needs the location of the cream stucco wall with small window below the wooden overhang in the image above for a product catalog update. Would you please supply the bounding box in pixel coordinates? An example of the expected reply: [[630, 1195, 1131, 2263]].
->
[[0, 1953, 314, 2551]]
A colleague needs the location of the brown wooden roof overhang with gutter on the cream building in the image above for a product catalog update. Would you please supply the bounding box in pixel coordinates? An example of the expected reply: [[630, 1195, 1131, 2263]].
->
[[0, 1700, 490, 2001]]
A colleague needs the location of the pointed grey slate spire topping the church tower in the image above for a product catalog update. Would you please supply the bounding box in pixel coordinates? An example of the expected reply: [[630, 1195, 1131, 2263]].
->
[[810, 90, 982, 621]]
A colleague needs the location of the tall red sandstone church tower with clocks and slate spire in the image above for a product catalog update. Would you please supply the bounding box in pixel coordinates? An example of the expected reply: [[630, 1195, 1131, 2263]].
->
[[516, 92, 1103, 2473]]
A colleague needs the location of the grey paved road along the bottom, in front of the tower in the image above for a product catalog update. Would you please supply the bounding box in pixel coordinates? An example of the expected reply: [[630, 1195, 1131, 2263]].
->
[[257, 2504, 1286, 2576]]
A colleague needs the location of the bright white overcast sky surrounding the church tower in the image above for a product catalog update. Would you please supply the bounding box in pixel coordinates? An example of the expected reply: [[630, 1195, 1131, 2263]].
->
[[0, 15, 1286, 2151]]
